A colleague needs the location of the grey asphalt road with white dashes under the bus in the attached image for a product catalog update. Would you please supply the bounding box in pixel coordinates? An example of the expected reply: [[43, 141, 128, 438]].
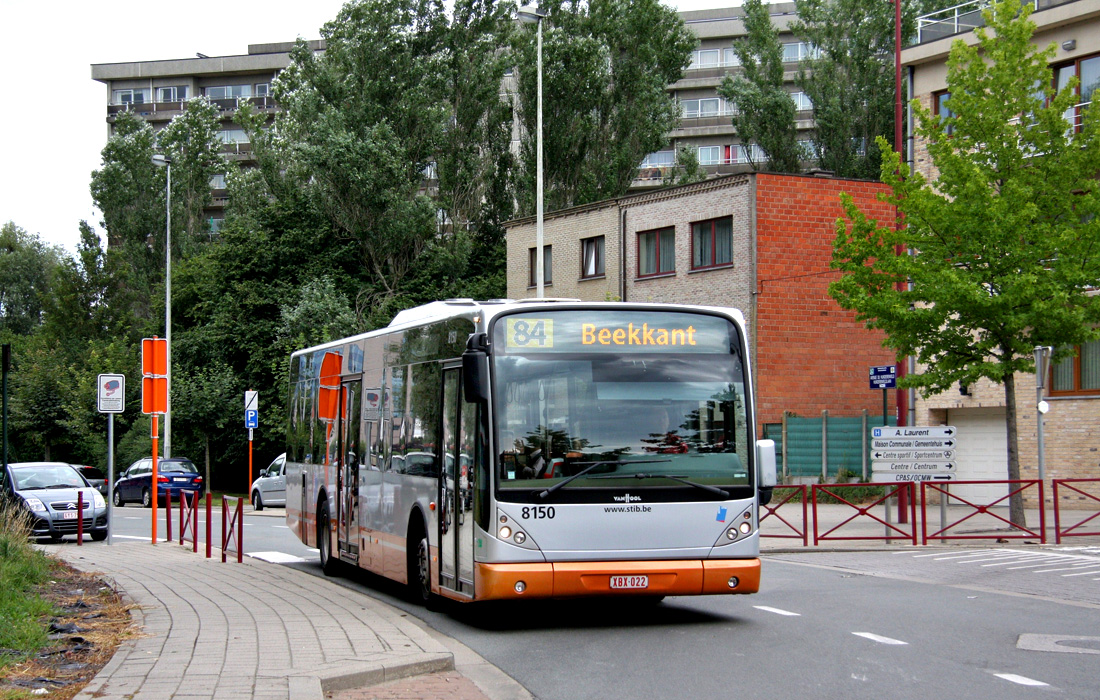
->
[[96, 508, 1100, 700]]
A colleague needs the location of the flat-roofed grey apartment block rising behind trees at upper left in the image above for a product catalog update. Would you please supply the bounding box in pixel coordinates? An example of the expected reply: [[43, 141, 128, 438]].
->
[[91, 41, 323, 231]]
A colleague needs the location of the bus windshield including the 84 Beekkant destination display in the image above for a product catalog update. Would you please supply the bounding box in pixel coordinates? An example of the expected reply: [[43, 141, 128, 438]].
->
[[493, 310, 751, 502]]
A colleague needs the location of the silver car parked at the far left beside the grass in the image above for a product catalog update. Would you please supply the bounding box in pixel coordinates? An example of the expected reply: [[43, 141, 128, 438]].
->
[[8, 462, 107, 542]]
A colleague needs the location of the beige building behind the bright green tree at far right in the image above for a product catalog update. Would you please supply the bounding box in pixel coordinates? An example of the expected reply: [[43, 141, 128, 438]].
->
[[901, 0, 1100, 507]]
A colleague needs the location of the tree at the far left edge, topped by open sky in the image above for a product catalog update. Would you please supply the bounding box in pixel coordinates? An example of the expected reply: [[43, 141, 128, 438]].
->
[[0, 221, 63, 336]]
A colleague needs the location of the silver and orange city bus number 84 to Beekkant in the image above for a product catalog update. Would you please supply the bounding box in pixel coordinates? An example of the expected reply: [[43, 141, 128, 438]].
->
[[286, 299, 776, 603]]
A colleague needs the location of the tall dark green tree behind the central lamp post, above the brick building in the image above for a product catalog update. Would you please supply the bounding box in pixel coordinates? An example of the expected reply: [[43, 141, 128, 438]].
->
[[516, 0, 696, 214]]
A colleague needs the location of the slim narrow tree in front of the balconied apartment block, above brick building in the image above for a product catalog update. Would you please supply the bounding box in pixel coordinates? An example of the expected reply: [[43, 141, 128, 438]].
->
[[718, 0, 802, 173]]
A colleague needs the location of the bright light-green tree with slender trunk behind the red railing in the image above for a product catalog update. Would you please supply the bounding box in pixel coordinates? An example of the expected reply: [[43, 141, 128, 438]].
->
[[829, 0, 1100, 524]]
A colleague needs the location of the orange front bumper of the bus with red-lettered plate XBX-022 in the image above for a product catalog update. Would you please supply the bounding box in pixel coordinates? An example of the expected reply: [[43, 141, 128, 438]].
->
[[474, 559, 760, 600]]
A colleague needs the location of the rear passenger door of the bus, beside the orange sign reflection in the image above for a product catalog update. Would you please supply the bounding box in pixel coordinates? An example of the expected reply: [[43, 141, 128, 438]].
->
[[337, 380, 363, 565]]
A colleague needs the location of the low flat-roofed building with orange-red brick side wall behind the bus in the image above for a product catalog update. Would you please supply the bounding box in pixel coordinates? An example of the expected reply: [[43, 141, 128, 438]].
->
[[507, 173, 894, 438]]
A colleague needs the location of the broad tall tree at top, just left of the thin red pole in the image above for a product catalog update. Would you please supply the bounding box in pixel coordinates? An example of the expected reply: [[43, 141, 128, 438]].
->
[[791, 0, 915, 178]]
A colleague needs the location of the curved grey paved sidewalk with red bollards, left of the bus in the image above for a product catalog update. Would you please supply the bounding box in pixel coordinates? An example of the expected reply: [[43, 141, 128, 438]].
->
[[54, 542, 530, 700]]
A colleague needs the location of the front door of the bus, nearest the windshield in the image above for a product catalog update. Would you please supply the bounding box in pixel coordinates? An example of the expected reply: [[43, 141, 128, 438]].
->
[[439, 368, 476, 597]]
